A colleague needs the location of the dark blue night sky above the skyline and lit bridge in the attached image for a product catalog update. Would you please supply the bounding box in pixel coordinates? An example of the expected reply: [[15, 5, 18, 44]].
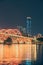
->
[[0, 0, 43, 34]]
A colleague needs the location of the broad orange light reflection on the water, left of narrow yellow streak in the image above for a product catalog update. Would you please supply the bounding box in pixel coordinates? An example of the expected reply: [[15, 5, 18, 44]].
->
[[0, 44, 31, 64]]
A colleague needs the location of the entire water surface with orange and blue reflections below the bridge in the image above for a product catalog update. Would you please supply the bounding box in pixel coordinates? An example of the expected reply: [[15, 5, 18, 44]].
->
[[0, 44, 43, 65]]
